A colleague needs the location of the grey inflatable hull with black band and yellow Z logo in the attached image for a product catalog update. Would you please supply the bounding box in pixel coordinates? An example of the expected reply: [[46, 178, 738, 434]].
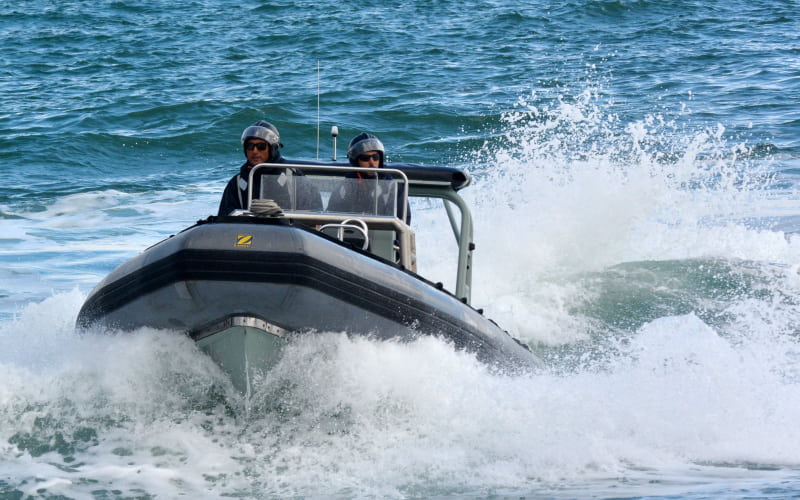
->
[[78, 217, 537, 389]]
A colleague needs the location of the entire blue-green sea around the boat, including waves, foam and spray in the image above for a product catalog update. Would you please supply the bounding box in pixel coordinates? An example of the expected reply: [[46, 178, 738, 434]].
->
[[0, 0, 800, 499]]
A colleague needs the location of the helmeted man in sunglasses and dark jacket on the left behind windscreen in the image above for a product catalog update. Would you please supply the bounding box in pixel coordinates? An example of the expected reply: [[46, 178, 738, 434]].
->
[[217, 120, 322, 216]]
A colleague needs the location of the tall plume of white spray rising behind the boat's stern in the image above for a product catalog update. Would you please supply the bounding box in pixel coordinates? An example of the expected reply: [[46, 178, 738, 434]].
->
[[460, 91, 800, 344]]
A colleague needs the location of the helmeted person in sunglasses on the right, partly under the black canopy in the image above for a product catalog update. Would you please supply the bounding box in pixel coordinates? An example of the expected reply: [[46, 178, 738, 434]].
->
[[328, 132, 411, 224]]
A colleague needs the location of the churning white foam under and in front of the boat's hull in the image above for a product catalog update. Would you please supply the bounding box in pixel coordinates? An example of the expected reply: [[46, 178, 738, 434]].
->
[[0, 286, 800, 497]]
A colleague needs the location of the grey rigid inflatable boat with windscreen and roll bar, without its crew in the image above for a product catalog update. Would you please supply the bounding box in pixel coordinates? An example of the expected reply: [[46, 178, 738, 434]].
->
[[77, 163, 538, 392]]
